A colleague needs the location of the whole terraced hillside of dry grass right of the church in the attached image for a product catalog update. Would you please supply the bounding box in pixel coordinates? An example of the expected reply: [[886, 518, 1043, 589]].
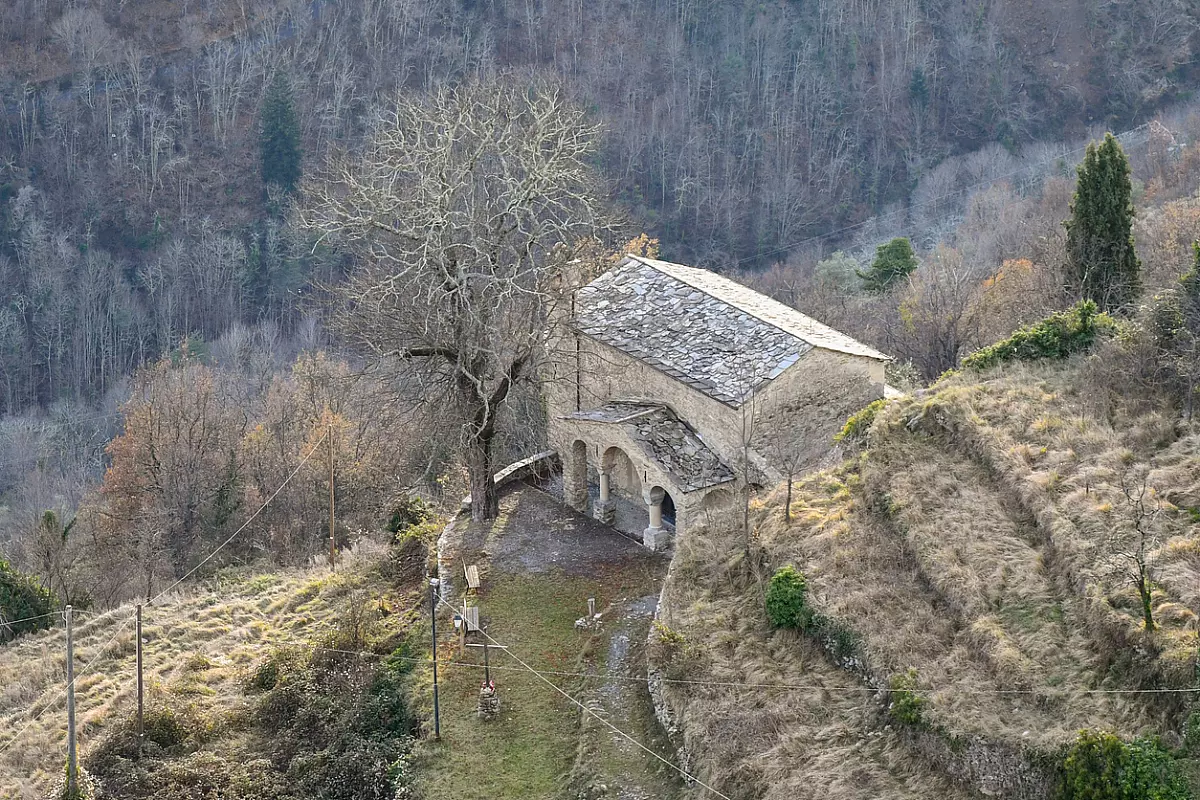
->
[[658, 361, 1200, 799]]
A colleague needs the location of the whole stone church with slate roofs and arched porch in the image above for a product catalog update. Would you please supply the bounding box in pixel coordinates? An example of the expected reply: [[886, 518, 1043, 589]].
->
[[547, 255, 888, 549]]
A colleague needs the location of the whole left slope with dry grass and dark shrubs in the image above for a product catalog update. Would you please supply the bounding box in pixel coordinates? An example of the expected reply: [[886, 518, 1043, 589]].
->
[[0, 543, 427, 800]]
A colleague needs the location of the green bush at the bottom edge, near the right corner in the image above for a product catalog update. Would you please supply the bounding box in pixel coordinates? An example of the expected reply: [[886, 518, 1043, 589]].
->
[[1058, 730, 1192, 800]]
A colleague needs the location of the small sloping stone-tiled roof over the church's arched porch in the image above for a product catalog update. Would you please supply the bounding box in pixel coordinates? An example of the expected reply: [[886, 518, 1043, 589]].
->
[[569, 402, 734, 492]]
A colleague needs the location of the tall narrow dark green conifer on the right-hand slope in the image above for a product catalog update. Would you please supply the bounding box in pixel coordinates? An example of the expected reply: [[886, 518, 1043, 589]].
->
[[1063, 133, 1141, 311]]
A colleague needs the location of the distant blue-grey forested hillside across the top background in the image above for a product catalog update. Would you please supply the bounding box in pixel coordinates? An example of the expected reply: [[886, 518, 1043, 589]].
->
[[0, 0, 1196, 410]]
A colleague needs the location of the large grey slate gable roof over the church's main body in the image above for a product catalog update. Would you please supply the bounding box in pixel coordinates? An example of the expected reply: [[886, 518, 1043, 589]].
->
[[576, 255, 887, 408]]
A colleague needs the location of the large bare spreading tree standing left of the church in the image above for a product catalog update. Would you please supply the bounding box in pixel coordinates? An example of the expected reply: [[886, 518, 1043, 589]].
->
[[300, 80, 605, 519]]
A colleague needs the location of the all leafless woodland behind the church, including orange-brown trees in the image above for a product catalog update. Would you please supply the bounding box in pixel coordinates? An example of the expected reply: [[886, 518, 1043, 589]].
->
[[0, 0, 1200, 596]]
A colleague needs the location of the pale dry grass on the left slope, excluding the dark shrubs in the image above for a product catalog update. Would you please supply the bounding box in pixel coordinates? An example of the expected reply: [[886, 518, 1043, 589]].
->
[[0, 554, 384, 800]]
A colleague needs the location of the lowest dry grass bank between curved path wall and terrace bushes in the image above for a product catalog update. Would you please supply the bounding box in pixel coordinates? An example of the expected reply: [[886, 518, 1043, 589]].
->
[[662, 530, 970, 800]]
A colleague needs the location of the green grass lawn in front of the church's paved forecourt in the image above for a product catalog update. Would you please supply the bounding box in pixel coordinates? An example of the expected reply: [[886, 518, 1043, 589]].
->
[[418, 567, 654, 800]]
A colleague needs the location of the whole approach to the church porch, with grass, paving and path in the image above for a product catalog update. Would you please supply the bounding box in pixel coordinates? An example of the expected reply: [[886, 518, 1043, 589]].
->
[[425, 486, 680, 800]]
